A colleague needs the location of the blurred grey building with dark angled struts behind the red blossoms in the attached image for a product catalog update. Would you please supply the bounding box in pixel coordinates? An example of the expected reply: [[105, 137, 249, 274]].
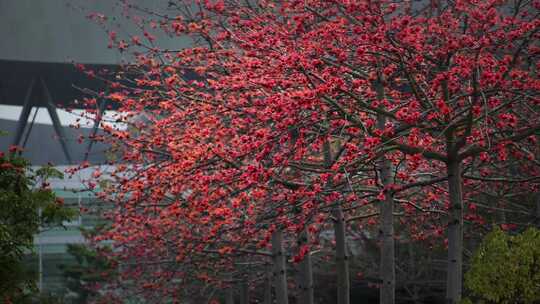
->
[[0, 0, 190, 300]]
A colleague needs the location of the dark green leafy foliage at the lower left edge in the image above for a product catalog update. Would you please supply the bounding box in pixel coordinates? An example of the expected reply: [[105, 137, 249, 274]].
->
[[0, 148, 73, 302]]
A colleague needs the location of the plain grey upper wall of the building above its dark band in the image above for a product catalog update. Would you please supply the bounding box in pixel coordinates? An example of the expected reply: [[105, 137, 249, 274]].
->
[[0, 0, 190, 64]]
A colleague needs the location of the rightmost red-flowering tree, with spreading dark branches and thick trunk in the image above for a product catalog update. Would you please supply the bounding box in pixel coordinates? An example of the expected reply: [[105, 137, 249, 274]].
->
[[348, 2, 540, 303]]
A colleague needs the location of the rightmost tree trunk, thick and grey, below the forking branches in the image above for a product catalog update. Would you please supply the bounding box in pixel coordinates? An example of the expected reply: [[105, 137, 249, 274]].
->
[[446, 158, 463, 304]]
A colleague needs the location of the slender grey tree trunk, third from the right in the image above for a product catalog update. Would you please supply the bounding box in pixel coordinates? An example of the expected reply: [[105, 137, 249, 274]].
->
[[333, 205, 350, 304]]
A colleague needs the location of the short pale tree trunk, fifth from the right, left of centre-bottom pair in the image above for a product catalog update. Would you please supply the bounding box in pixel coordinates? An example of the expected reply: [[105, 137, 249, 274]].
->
[[272, 229, 289, 304]]
